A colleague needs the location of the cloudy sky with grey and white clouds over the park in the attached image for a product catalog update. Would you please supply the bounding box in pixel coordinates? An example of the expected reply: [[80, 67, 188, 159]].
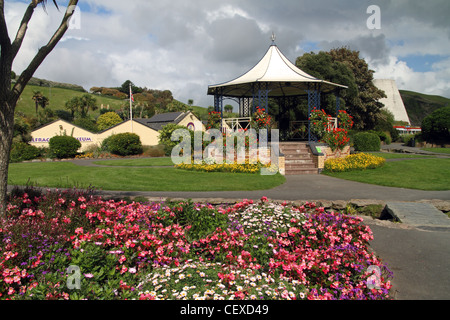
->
[[5, 0, 450, 107]]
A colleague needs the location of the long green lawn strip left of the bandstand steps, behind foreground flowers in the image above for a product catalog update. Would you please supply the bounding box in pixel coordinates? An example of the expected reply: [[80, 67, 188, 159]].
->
[[8, 162, 286, 191]]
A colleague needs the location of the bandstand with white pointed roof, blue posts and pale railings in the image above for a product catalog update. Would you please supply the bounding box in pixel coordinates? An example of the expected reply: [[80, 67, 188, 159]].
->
[[208, 36, 347, 142]]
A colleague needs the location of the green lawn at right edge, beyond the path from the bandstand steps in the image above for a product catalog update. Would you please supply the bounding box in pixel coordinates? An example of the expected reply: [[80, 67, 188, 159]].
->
[[324, 158, 450, 190]]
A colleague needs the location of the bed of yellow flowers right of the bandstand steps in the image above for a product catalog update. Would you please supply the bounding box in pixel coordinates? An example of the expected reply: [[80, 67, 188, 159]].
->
[[324, 153, 386, 172]]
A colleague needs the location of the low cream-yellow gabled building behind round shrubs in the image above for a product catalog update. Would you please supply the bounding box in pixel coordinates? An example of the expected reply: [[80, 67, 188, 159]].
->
[[30, 111, 205, 151]]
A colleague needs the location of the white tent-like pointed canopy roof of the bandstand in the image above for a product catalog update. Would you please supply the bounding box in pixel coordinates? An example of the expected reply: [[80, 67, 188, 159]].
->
[[208, 44, 347, 97]]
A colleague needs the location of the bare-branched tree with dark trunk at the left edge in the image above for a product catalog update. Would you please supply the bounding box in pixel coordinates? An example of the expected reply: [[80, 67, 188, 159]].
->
[[0, 0, 78, 215]]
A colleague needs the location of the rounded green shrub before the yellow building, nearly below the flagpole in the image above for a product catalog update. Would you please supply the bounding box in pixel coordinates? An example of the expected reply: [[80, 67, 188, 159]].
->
[[102, 132, 143, 156]]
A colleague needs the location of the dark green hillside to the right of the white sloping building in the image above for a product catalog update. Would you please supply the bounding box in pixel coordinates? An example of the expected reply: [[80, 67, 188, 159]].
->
[[399, 90, 450, 126]]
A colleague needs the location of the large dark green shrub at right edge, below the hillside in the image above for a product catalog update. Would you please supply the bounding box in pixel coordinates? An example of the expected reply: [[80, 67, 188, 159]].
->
[[422, 107, 450, 142]]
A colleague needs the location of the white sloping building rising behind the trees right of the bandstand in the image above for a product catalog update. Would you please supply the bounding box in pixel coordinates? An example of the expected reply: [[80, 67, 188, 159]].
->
[[373, 79, 411, 125]]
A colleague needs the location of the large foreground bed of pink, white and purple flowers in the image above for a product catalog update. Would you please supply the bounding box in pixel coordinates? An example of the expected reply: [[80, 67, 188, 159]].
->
[[0, 190, 390, 299]]
